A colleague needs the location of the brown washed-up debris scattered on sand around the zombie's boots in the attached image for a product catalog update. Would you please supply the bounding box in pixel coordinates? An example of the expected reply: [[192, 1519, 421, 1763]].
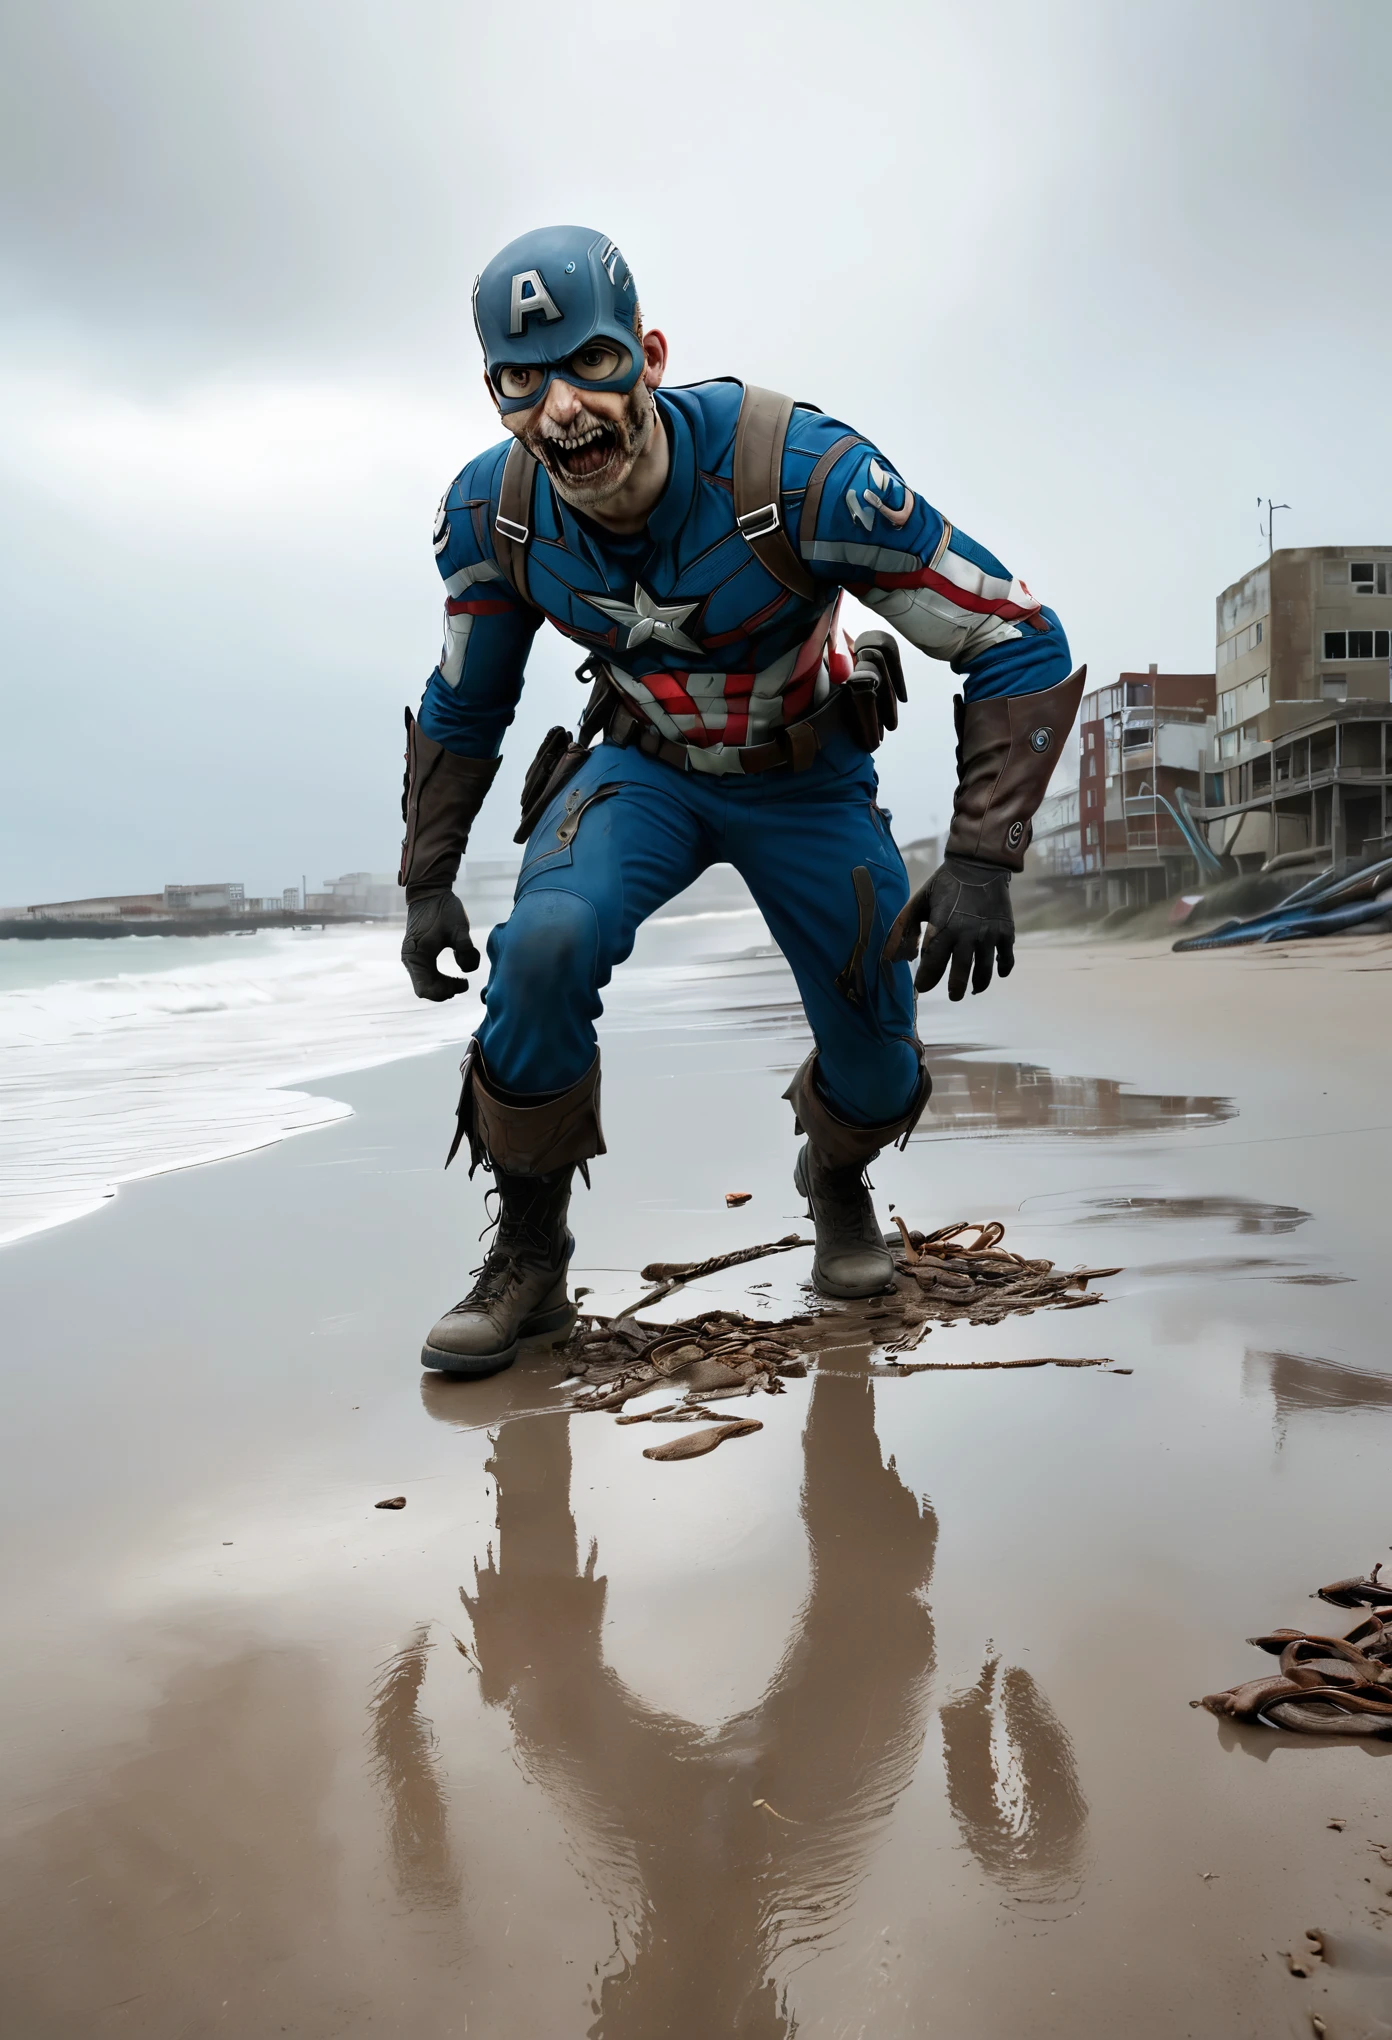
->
[[565, 1220, 1121, 1459]]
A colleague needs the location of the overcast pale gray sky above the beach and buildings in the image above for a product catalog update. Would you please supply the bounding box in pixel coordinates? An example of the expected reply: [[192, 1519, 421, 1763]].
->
[[0, 0, 1392, 904]]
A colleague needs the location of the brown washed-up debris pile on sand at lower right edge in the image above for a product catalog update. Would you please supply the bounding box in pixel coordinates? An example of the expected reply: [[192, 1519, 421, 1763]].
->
[[1190, 1565, 1392, 1736]]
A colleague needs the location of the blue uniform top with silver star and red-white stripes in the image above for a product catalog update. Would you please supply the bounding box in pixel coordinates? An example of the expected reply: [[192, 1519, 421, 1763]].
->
[[420, 381, 1070, 771]]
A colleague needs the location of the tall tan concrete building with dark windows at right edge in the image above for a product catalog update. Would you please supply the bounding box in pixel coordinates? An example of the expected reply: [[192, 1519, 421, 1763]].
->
[[1204, 545, 1392, 869]]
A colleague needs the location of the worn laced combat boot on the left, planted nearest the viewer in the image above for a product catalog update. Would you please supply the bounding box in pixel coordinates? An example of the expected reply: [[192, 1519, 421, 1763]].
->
[[420, 1165, 576, 1379]]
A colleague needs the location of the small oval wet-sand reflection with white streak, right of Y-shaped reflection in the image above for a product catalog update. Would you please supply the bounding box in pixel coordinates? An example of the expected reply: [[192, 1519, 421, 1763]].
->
[[943, 1656, 1088, 1901]]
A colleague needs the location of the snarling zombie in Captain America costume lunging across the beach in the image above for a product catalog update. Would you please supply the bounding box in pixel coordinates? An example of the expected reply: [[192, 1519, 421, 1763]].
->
[[402, 228, 1084, 1375]]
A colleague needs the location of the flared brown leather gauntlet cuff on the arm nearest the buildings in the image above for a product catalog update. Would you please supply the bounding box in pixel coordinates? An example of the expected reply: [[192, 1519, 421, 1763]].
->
[[945, 665, 1088, 871]]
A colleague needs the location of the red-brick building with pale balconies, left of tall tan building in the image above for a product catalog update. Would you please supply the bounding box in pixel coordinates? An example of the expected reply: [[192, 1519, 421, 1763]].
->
[[1078, 667, 1214, 908]]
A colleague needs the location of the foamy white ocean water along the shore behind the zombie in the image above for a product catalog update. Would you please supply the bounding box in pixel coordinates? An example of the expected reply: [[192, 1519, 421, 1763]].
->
[[0, 871, 782, 1242]]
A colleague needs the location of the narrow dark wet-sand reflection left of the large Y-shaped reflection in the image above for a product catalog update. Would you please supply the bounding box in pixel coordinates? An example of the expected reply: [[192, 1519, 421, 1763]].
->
[[369, 1628, 459, 1907]]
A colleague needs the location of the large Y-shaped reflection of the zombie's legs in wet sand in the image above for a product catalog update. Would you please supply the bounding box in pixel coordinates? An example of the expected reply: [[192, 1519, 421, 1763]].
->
[[438, 1355, 937, 2040]]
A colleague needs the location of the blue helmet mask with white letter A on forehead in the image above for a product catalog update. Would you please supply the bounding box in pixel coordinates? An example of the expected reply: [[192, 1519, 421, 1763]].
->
[[474, 226, 643, 414]]
